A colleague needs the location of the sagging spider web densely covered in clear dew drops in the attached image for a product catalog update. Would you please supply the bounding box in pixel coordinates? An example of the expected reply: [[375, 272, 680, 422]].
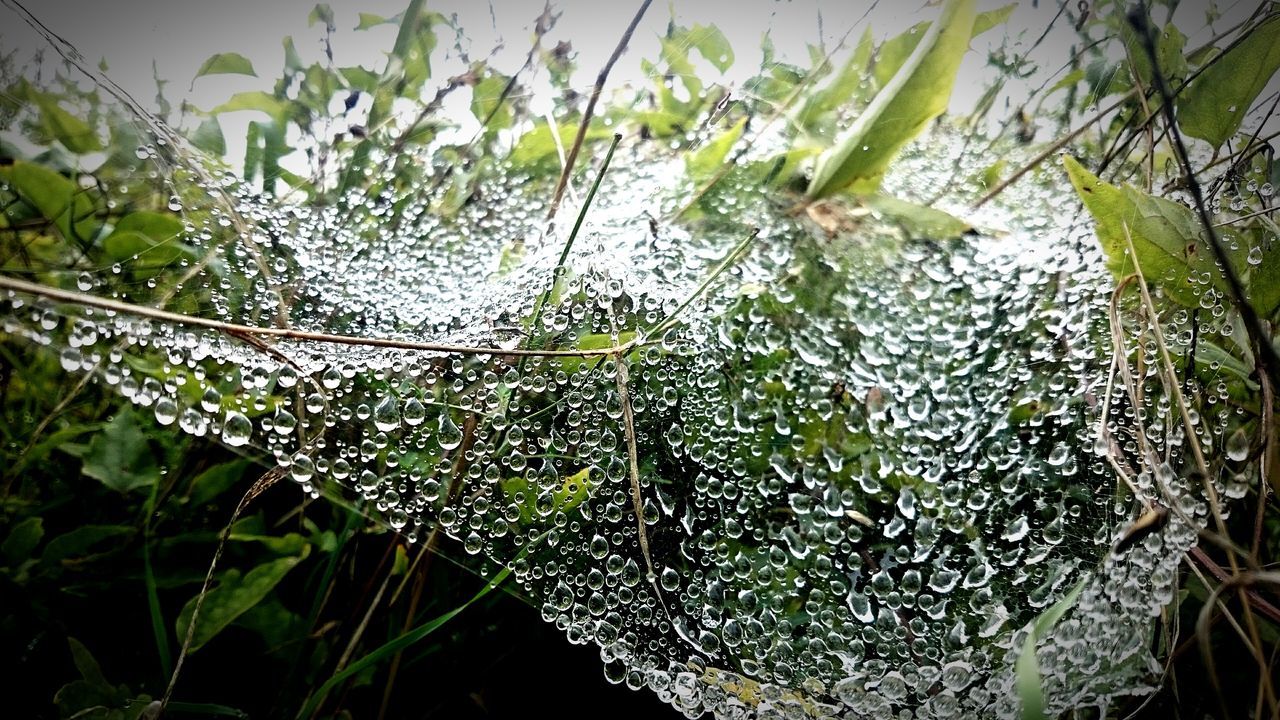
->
[[0, 2, 1264, 719]]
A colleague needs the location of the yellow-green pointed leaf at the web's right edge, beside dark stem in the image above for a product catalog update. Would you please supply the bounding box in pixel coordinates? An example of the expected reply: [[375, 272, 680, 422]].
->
[[1062, 155, 1229, 307]]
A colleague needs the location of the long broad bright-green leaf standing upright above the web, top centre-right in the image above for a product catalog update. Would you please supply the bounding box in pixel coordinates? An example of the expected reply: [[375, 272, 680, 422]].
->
[[808, 0, 975, 199]]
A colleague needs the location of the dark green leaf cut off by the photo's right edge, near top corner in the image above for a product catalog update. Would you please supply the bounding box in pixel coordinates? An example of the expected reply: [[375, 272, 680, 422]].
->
[[1178, 15, 1280, 147]]
